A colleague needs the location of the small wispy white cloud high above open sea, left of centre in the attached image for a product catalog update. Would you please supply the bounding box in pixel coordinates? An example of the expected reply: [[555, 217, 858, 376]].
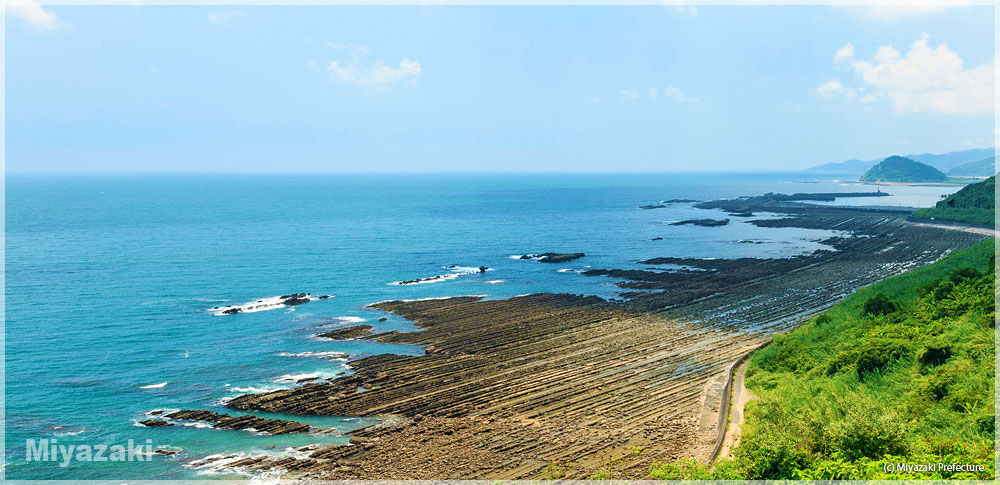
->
[[326, 42, 423, 90]]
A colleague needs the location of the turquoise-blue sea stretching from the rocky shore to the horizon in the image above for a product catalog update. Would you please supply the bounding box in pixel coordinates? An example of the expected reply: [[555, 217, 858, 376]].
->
[[4, 173, 955, 479]]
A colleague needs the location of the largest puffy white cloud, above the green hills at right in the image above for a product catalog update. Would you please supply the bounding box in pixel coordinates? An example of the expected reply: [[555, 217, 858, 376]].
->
[[816, 34, 995, 114]]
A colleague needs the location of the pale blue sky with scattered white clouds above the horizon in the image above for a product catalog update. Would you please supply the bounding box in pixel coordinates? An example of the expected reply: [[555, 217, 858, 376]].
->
[[5, 0, 996, 173]]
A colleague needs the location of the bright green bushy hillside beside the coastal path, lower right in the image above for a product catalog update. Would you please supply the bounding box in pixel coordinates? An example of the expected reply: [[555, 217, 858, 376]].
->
[[650, 240, 996, 479]]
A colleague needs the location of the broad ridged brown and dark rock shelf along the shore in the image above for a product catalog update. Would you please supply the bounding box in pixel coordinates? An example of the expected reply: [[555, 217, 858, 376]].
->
[[170, 189, 983, 479]]
